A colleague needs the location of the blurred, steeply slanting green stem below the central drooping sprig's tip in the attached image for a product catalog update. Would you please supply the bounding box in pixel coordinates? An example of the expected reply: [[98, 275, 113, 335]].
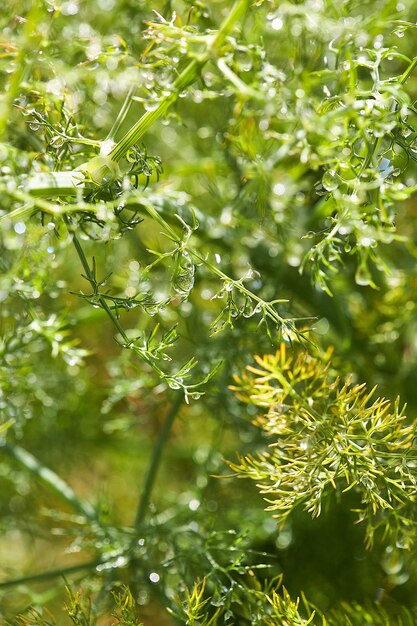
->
[[135, 393, 185, 528]]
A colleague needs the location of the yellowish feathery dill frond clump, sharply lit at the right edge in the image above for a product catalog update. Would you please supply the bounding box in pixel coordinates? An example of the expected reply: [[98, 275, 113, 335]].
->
[[232, 344, 416, 547]]
